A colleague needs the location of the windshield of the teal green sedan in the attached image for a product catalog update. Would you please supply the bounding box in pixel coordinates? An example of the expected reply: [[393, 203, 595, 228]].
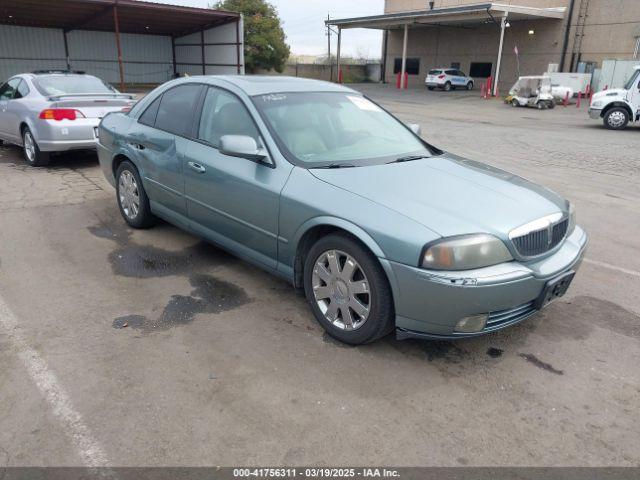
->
[[253, 92, 433, 168]]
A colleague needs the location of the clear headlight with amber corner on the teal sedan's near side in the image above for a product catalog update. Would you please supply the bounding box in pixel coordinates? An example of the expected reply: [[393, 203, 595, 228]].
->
[[421, 233, 513, 270]]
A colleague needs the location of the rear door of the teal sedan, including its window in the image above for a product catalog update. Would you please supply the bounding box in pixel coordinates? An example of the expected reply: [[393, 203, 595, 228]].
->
[[127, 84, 202, 223]]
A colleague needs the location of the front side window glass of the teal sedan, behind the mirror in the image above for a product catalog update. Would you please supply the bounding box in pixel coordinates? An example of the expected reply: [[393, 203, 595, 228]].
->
[[198, 87, 259, 148]]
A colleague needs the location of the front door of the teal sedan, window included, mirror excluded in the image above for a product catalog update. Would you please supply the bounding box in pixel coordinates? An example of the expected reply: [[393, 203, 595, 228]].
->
[[184, 87, 293, 269]]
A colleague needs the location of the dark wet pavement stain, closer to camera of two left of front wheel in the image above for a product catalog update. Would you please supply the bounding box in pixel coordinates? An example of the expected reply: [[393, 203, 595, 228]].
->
[[113, 274, 251, 333]]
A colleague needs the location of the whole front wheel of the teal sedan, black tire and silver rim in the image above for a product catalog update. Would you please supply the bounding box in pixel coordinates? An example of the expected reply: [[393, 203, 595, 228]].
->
[[304, 233, 395, 345]]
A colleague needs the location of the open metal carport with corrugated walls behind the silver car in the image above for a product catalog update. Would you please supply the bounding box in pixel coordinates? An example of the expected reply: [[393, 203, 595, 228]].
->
[[0, 0, 244, 89]]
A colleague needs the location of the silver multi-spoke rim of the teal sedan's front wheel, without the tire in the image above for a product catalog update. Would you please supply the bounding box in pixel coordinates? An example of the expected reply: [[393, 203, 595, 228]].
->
[[311, 250, 371, 331]]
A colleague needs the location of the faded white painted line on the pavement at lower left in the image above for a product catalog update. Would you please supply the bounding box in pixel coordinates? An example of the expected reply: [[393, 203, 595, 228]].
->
[[0, 297, 109, 468]]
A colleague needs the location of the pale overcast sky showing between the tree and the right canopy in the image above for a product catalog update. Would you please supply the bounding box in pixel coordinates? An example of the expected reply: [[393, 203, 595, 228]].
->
[[154, 0, 384, 58]]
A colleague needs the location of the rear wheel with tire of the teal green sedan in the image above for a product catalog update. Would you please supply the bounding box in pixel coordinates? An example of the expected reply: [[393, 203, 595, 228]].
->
[[116, 160, 156, 228]]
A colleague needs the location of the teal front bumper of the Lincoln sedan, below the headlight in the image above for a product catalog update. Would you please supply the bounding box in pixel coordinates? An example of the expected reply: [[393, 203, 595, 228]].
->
[[390, 227, 587, 339]]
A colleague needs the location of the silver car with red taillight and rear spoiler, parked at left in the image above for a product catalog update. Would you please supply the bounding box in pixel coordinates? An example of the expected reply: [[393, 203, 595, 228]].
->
[[0, 71, 134, 167]]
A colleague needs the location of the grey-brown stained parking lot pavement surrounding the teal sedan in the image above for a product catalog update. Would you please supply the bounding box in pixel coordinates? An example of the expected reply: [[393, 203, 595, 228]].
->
[[0, 85, 640, 466]]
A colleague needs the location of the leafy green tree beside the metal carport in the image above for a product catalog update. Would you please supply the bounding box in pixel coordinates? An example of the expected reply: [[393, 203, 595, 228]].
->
[[213, 0, 290, 73]]
